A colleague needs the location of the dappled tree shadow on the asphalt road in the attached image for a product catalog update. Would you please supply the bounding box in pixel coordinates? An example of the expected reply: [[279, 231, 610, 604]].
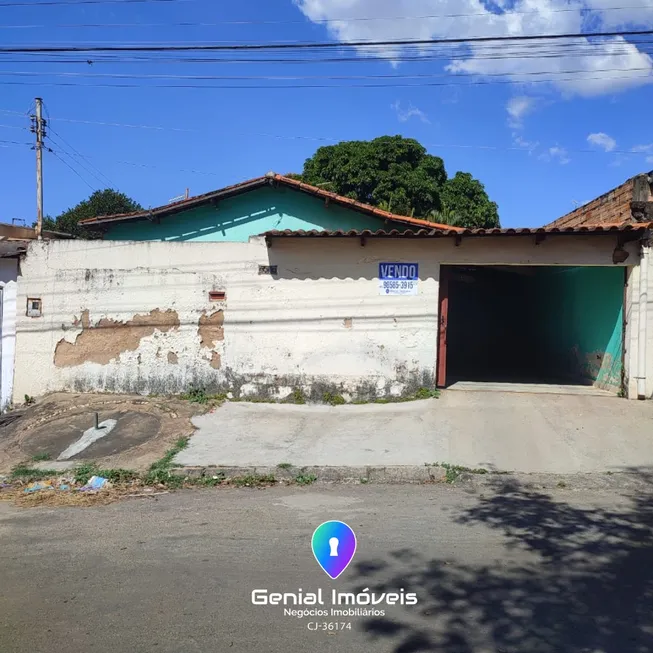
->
[[354, 470, 653, 653]]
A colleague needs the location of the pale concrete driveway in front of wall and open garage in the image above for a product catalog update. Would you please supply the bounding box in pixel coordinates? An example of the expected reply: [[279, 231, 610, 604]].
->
[[176, 392, 653, 474]]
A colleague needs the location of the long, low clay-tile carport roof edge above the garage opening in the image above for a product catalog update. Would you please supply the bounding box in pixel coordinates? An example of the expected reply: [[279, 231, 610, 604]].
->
[[262, 222, 653, 238]]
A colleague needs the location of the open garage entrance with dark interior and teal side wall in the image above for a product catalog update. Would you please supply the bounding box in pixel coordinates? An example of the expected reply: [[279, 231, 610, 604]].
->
[[438, 266, 625, 393]]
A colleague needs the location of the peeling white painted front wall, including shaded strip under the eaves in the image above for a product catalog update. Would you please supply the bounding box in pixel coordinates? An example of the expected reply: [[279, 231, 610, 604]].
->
[[14, 236, 640, 399]]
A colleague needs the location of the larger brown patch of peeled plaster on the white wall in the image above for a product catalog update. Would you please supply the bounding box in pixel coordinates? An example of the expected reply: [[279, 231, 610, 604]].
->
[[54, 308, 180, 367]]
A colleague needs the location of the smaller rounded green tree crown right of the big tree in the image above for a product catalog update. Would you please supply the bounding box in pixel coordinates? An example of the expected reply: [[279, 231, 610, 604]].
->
[[442, 172, 500, 229]]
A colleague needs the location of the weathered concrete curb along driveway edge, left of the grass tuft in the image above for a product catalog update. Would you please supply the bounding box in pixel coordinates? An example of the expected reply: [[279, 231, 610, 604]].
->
[[170, 465, 446, 484]]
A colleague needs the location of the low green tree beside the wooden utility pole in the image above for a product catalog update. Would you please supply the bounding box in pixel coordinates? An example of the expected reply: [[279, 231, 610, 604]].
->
[[43, 188, 143, 238]]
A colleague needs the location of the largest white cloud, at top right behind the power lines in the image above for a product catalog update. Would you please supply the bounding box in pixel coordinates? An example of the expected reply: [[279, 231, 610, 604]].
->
[[294, 0, 653, 96]]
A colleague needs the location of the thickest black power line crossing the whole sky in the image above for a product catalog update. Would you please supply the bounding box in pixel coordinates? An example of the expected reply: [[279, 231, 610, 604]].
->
[[0, 28, 653, 54]]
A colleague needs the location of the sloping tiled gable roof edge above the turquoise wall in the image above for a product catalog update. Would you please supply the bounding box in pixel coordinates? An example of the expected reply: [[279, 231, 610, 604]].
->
[[80, 172, 457, 230]]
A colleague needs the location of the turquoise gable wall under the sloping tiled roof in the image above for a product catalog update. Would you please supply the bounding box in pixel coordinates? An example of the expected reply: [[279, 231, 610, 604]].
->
[[105, 188, 408, 242]]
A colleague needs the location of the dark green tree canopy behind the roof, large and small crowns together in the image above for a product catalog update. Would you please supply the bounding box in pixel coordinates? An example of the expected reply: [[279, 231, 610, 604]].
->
[[301, 136, 499, 228]]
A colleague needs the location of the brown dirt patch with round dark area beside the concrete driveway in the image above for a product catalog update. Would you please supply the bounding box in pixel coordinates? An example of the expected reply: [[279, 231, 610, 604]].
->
[[0, 393, 204, 472]]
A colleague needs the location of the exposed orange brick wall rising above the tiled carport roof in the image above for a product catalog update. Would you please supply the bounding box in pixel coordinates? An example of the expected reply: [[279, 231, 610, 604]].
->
[[547, 175, 652, 228]]
